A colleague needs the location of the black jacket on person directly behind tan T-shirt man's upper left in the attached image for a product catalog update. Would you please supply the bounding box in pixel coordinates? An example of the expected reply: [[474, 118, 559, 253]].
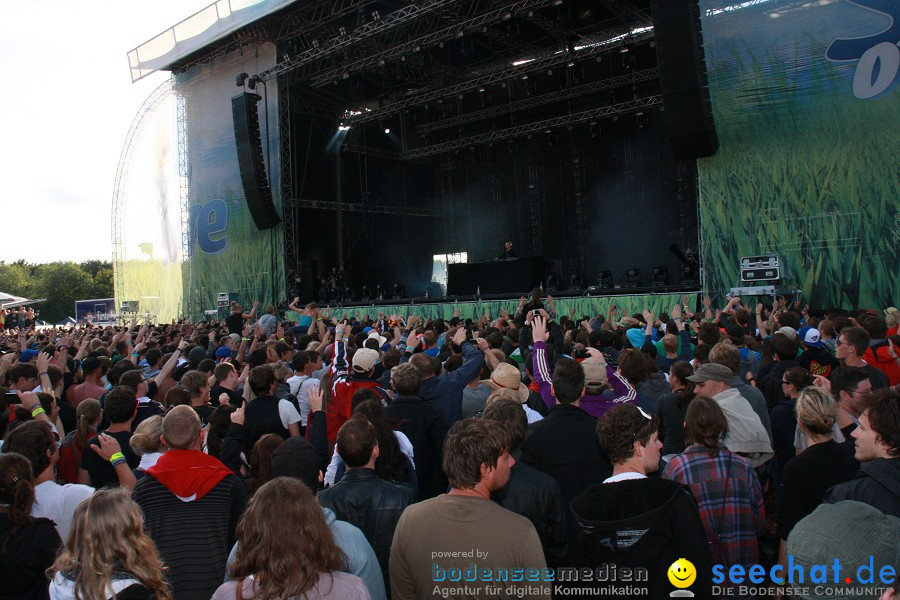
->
[[387, 395, 449, 500]]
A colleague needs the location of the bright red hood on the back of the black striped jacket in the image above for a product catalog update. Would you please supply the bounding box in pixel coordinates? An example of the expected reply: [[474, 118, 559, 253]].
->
[[147, 450, 232, 502]]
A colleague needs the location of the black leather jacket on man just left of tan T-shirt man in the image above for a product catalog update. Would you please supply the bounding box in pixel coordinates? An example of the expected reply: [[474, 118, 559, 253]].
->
[[319, 468, 415, 585]]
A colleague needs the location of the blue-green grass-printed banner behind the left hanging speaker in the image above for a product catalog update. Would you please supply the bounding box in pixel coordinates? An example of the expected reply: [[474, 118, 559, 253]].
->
[[175, 44, 284, 318]]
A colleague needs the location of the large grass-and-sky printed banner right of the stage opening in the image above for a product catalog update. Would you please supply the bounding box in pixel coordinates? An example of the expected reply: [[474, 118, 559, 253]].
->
[[699, 0, 900, 308]]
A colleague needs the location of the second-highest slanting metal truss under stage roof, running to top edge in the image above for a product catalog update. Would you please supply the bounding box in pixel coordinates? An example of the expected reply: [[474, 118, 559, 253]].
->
[[309, 0, 564, 87]]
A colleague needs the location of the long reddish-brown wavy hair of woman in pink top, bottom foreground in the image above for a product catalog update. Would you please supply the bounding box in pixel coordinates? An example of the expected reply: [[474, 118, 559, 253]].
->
[[229, 477, 346, 600]]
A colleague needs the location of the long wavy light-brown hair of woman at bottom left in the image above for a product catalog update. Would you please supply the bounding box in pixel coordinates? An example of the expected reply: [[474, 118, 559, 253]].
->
[[47, 488, 172, 600]]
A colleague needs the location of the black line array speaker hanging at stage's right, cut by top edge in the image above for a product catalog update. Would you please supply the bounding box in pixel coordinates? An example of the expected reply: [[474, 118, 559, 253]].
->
[[650, 0, 719, 160]]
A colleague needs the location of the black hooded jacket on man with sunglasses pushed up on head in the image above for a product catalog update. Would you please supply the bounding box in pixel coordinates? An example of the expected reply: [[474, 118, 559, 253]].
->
[[572, 477, 712, 598]]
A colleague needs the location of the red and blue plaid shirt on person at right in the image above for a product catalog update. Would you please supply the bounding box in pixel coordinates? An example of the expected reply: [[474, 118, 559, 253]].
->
[[662, 445, 765, 567]]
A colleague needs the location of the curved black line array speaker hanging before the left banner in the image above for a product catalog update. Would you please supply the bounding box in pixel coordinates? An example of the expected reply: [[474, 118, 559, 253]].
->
[[231, 92, 281, 229]]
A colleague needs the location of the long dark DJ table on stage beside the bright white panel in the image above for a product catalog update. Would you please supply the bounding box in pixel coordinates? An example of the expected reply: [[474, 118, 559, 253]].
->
[[447, 256, 544, 296]]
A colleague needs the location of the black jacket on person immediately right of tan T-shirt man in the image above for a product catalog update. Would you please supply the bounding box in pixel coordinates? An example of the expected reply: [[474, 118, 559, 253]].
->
[[491, 450, 569, 568]]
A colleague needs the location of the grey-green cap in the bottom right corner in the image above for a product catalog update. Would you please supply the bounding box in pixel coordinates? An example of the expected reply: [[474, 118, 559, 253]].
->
[[787, 500, 900, 600]]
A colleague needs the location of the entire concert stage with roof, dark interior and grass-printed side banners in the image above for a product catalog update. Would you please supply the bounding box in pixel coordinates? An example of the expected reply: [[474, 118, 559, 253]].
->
[[113, 0, 900, 317]]
